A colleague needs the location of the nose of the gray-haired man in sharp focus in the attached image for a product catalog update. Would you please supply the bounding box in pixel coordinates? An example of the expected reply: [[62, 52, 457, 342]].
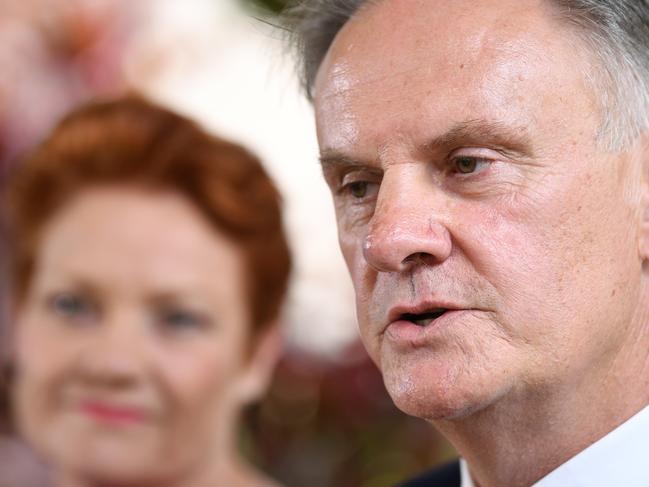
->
[[363, 179, 452, 272]]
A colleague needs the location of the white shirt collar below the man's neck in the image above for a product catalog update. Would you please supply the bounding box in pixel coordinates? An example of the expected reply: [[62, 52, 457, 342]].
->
[[460, 406, 649, 487]]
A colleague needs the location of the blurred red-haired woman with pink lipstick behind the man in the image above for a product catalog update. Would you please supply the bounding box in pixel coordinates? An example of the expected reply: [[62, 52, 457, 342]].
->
[[1, 97, 290, 487]]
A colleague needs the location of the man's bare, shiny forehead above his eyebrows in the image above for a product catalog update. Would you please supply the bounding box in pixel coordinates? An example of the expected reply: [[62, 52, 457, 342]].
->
[[315, 0, 594, 158]]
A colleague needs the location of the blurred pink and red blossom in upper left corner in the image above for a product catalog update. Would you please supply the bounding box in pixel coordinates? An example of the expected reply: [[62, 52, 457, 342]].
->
[[0, 0, 145, 169]]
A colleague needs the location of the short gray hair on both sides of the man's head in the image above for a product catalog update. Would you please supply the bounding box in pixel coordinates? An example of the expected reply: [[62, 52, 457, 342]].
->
[[286, 0, 649, 150]]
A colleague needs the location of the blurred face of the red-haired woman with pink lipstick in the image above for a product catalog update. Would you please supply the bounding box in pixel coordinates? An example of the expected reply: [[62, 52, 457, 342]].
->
[[15, 187, 270, 483]]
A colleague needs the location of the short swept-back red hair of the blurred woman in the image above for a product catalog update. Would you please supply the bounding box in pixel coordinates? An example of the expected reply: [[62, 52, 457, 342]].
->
[[6, 96, 291, 329]]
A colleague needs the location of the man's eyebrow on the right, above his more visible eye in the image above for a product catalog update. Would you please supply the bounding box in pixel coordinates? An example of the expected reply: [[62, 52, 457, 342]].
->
[[421, 119, 532, 156]]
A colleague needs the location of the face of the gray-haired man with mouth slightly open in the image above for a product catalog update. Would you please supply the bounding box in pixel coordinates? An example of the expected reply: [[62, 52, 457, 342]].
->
[[315, 0, 641, 419]]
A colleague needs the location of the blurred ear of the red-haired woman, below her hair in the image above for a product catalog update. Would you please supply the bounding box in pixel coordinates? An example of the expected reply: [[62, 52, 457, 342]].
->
[[237, 322, 284, 404]]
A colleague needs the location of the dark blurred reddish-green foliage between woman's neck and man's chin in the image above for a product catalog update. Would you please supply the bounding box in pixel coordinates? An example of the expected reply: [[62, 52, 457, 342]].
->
[[242, 343, 455, 487]]
